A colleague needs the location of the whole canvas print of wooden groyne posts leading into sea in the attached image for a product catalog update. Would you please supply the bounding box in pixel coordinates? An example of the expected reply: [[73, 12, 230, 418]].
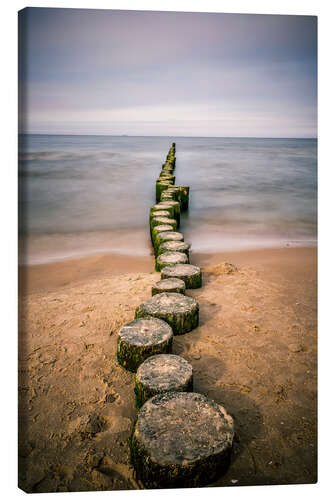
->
[[18, 8, 317, 493]]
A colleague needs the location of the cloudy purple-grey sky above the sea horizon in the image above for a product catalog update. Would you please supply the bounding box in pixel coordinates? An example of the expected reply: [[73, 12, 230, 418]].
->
[[19, 8, 317, 138]]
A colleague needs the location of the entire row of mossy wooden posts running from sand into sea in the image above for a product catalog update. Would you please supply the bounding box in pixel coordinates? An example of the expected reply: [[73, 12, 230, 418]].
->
[[117, 143, 234, 488]]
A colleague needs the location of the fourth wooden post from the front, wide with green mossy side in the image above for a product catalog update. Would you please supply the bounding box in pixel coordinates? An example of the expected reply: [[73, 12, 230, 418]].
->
[[135, 292, 199, 335]]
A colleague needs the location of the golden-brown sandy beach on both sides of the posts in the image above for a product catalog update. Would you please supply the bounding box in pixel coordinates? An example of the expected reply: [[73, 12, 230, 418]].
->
[[19, 247, 317, 492]]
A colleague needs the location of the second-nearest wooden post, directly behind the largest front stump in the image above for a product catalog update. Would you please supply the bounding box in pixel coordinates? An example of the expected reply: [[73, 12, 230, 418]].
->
[[134, 354, 193, 408]]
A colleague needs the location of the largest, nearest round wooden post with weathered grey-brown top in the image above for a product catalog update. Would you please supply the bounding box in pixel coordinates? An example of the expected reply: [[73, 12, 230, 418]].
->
[[130, 392, 234, 488]]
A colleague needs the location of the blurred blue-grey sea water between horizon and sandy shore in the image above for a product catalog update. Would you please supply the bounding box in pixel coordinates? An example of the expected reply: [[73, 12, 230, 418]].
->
[[19, 135, 317, 264]]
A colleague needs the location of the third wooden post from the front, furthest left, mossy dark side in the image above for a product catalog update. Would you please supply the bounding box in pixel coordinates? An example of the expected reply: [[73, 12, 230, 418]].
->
[[117, 316, 173, 372]]
